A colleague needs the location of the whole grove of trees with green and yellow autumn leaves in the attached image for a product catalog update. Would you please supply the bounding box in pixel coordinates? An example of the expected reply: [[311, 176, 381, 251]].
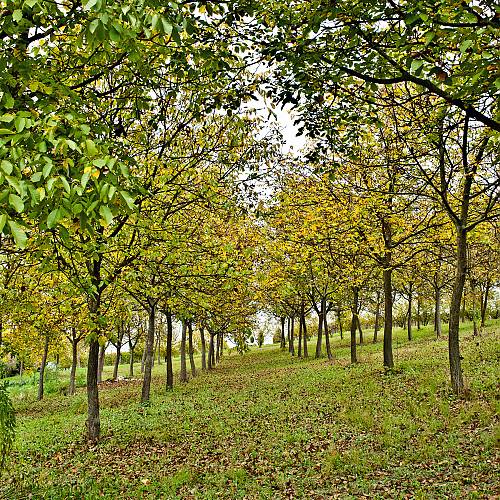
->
[[0, 0, 500, 450]]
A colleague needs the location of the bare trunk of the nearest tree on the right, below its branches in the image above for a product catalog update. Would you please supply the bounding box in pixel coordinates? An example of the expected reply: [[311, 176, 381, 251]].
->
[[448, 227, 467, 394]]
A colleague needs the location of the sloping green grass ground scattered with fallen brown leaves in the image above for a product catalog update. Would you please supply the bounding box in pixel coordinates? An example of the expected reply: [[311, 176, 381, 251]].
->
[[0, 322, 500, 499]]
